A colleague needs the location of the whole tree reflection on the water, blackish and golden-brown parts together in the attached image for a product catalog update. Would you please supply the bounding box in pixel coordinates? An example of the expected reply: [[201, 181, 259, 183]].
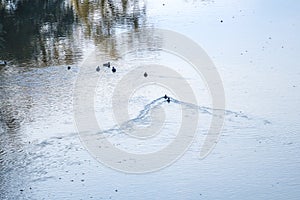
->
[[0, 0, 146, 67]]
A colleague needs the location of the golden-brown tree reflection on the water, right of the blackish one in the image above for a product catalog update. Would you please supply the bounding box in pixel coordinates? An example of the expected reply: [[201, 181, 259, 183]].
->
[[72, 0, 146, 56]]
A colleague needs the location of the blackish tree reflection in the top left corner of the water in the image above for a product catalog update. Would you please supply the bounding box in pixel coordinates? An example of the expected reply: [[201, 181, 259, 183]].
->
[[0, 0, 74, 65]]
